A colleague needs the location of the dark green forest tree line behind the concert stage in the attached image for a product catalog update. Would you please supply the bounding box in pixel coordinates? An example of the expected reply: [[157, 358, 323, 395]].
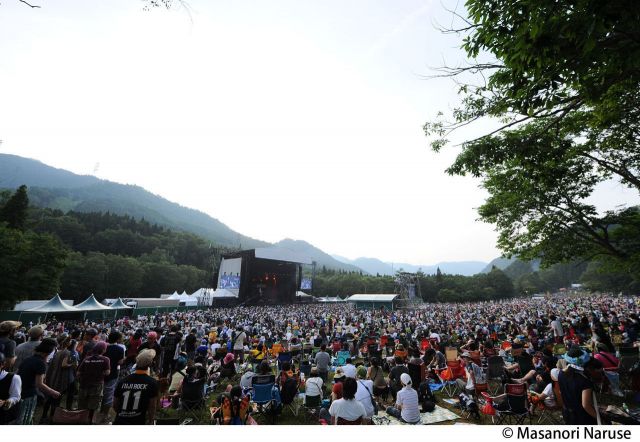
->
[[0, 187, 631, 309]]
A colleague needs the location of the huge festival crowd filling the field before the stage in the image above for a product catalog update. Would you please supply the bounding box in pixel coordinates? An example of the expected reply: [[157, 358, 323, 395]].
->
[[0, 295, 640, 425]]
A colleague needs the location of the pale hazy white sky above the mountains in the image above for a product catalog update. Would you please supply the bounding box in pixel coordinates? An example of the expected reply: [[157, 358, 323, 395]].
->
[[0, 0, 632, 264]]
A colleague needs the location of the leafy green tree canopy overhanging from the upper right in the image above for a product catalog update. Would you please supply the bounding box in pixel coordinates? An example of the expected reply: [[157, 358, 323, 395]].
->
[[424, 0, 640, 277]]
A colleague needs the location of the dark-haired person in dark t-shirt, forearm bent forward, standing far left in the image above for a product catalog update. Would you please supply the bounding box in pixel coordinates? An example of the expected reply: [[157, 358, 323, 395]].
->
[[17, 338, 60, 425]]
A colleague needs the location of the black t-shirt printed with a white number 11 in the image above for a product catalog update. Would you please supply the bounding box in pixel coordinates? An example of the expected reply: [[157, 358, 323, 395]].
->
[[113, 373, 158, 425]]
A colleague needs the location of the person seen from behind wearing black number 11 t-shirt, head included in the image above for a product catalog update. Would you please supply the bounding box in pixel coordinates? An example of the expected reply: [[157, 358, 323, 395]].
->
[[113, 349, 158, 425]]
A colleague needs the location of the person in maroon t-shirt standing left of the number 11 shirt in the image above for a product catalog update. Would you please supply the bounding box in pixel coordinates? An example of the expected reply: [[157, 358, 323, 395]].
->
[[78, 341, 111, 423]]
